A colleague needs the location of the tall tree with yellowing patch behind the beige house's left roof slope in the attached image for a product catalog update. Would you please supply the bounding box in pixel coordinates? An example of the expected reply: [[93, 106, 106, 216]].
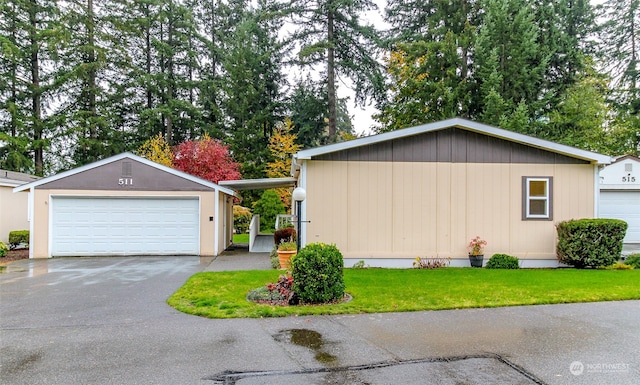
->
[[376, 0, 478, 131]]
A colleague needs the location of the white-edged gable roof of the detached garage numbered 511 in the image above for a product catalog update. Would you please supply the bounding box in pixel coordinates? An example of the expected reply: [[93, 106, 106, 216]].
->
[[13, 152, 236, 196]]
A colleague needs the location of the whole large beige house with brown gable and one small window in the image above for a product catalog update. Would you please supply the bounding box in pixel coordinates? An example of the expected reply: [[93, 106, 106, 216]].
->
[[292, 118, 611, 267]]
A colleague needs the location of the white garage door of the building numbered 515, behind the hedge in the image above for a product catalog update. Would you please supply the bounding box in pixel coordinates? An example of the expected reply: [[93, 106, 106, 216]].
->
[[599, 191, 640, 243]]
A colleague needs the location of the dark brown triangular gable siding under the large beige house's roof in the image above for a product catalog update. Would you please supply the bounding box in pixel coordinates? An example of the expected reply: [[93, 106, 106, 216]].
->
[[313, 127, 589, 164]]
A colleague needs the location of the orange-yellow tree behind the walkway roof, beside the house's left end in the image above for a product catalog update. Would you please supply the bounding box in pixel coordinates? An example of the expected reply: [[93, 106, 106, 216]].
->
[[266, 118, 301, 209]]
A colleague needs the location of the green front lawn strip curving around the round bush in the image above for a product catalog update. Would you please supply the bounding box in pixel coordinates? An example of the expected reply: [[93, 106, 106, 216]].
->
[[168, 268, 640, 318]]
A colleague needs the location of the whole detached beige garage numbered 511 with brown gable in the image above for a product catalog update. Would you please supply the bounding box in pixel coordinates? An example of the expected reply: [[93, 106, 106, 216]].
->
[[14, 153, 235, 258]]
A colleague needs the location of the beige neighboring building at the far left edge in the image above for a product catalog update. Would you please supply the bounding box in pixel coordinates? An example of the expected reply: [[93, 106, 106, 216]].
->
[[0, 170, 38, 243]]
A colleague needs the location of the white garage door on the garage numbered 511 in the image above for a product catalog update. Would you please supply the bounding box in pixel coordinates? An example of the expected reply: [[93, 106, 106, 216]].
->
[[51, 197, 200, 257]]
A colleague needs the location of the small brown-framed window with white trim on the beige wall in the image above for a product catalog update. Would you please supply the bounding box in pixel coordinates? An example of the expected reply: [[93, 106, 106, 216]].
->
[[522, 176, 553, 220]]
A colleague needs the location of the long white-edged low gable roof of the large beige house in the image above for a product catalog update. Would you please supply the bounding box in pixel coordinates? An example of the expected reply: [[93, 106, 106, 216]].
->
[[292, 118, 613, 165]]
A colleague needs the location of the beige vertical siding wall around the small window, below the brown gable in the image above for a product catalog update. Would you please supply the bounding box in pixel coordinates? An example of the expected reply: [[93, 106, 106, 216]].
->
[[306, 160, 594, 259]]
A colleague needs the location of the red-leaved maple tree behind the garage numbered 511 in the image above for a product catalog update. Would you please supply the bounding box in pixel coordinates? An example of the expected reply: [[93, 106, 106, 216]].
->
[[173, 135, 242, 183]]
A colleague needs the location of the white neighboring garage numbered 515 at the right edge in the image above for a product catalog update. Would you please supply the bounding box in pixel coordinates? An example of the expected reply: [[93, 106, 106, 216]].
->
[[599, 155, 640, 254]]
